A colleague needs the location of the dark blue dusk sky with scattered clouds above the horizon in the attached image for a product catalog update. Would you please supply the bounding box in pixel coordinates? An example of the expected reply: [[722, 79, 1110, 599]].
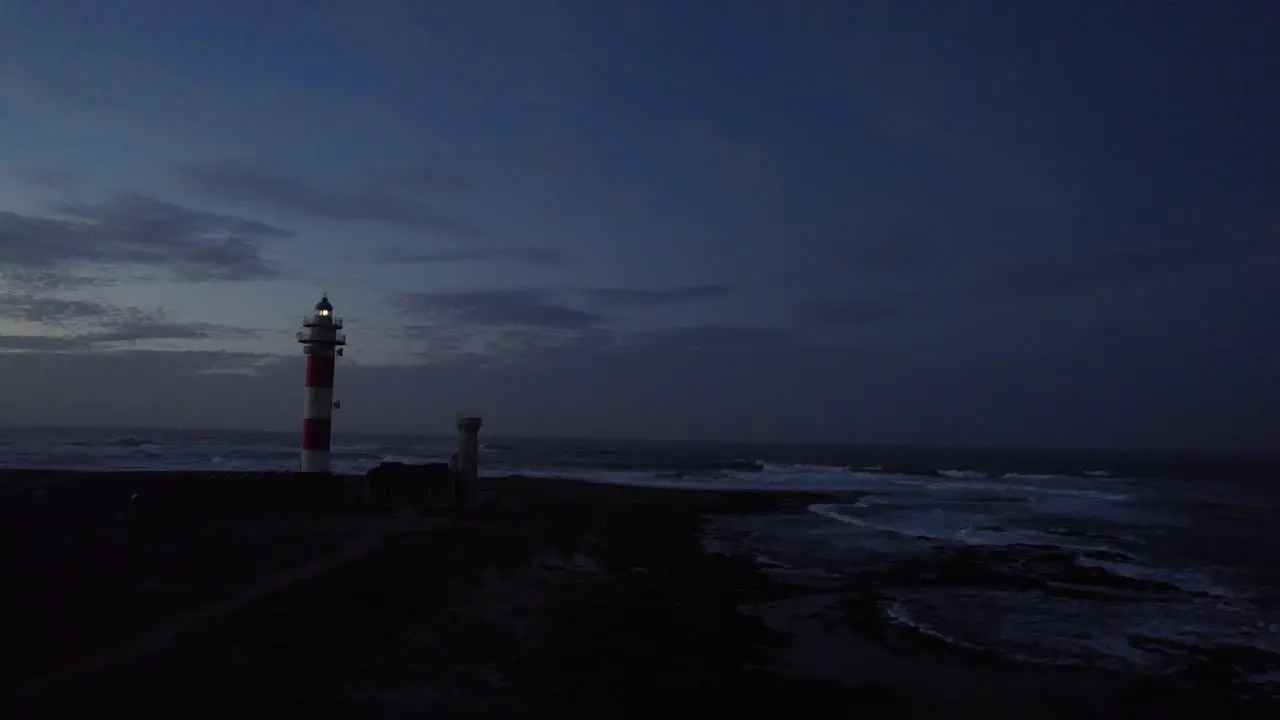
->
[[0, 0, 1280, 448]]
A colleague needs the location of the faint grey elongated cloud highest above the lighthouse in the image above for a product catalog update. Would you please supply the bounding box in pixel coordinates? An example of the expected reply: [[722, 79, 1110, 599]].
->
[[177, 163, 480, 237]]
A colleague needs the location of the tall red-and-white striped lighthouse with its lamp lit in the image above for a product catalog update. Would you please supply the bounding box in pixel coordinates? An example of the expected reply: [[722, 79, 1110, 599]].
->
[[298, 295, 347, 473]]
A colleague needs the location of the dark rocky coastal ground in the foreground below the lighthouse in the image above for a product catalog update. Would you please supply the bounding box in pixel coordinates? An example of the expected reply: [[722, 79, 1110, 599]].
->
[[0, 473, 1274, 717]]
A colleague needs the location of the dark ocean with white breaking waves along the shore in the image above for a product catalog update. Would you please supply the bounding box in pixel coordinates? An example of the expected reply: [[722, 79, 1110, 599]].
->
[[0, 428, 1280, 688]]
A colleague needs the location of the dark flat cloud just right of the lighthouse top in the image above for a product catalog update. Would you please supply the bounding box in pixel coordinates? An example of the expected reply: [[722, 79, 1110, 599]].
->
[[393, 290, 607, 329]]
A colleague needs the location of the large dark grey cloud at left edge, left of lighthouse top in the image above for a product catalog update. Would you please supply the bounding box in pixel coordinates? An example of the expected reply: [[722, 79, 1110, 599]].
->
[[0, 195, 291, 281]]
